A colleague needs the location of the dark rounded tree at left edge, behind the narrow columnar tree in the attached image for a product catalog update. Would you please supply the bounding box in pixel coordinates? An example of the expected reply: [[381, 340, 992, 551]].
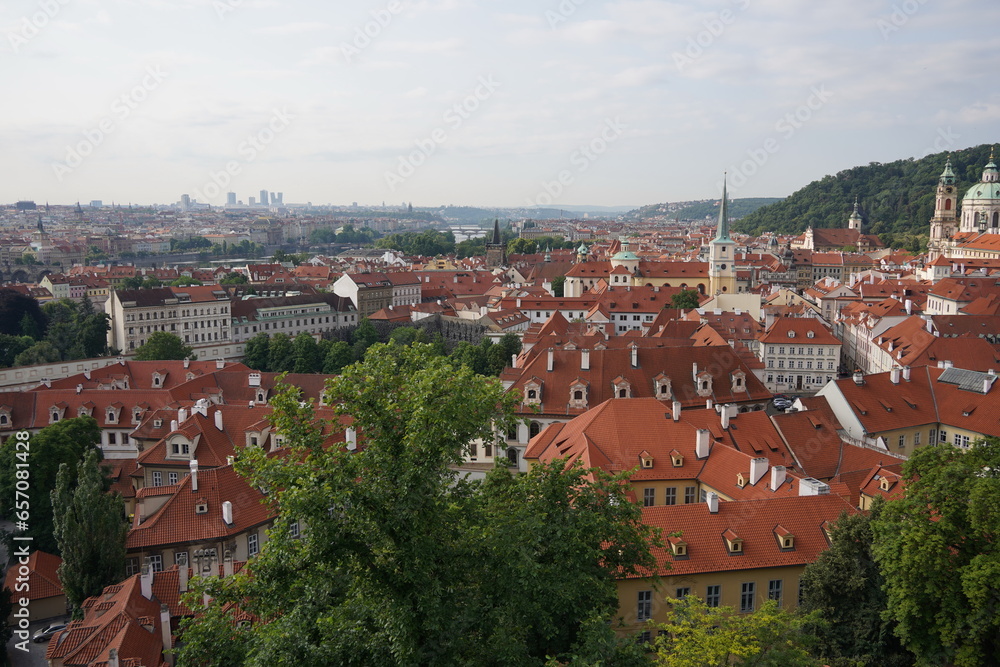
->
[[0, 417, 101, 554]]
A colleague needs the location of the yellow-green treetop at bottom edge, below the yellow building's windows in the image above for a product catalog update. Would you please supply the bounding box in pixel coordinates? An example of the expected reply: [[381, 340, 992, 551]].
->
[[655, 595, 823, 667]]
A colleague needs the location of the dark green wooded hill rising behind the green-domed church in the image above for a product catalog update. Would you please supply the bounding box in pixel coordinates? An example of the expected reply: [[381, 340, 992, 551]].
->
[[733, 145, 991, 240]]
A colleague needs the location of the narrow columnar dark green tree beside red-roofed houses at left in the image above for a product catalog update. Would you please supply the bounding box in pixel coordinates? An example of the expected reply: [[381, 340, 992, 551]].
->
[[52, 450, 128, 617]]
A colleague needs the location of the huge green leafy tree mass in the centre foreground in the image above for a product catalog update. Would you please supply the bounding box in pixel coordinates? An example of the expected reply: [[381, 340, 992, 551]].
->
[[180, 344, 653, 666]]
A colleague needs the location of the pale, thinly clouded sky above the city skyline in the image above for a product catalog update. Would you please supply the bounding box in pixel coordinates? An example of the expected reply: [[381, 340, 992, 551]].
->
[[0, 0, 1000, 207]]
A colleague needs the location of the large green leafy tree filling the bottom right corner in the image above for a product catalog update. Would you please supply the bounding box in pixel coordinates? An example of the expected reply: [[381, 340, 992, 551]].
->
[[872, 438, 1000, 667]]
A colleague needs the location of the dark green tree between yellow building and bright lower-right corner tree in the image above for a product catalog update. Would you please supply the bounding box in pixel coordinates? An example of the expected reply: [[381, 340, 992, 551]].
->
[[799, 503, 913, 667]]
